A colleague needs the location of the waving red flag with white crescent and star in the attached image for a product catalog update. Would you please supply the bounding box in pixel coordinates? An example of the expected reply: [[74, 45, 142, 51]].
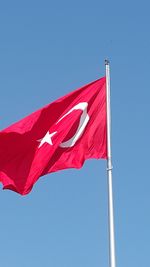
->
[[0, 77, 107, 195]]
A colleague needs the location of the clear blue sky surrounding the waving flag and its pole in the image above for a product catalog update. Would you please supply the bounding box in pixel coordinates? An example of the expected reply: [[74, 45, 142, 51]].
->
[[0, 0, 150, 267]]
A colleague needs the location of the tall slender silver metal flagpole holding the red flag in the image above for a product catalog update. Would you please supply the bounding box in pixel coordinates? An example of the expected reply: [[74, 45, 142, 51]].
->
[[105, 60, 116, 267]]
